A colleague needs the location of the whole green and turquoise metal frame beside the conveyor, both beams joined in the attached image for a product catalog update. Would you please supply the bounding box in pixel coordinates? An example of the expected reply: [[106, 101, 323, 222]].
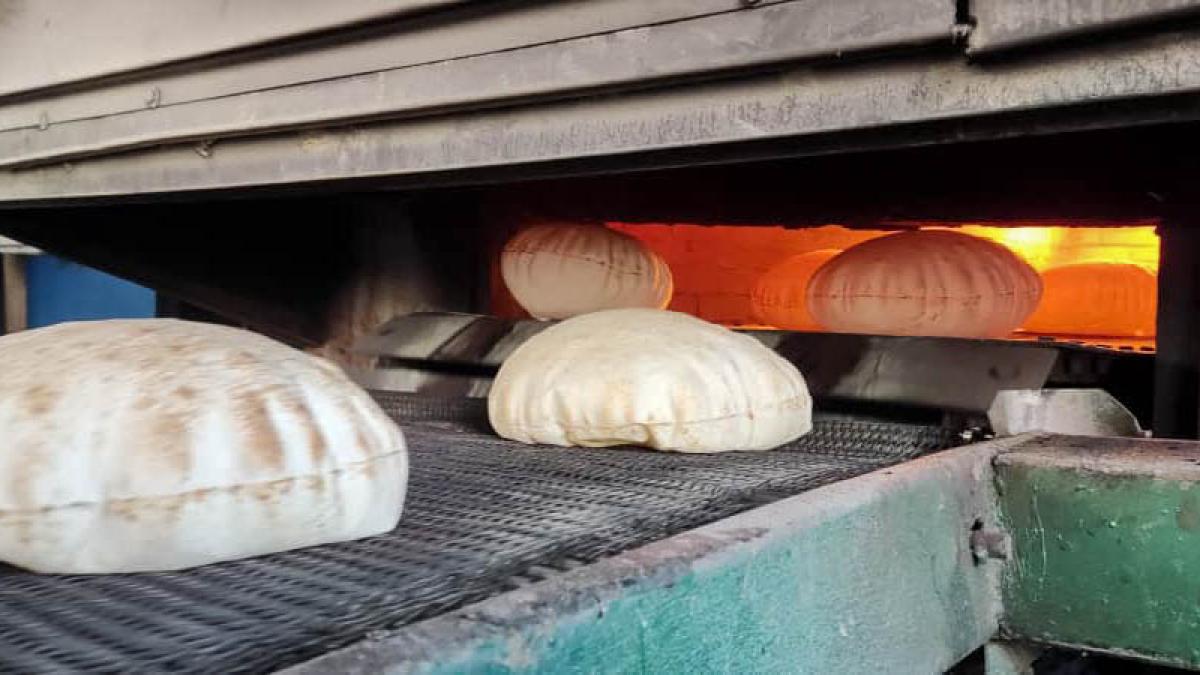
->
[[276, 436, 1200, 675]]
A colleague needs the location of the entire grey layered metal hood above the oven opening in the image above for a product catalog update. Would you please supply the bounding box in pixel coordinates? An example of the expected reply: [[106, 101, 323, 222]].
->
[[0, 0, 1200, 204]]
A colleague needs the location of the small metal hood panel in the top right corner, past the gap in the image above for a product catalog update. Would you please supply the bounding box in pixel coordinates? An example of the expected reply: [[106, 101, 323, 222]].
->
[[968, 0, 1200, 53]]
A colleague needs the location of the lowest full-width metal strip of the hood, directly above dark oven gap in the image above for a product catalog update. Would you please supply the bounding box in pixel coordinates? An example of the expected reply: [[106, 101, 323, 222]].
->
[[0, 28, 1200, 203]]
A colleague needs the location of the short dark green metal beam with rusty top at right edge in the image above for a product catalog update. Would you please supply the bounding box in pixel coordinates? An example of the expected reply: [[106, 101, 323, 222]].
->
[[997, 437, 1200, 668]]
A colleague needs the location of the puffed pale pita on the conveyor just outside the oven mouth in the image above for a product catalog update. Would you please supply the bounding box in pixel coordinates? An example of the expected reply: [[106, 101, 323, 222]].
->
[[487, 309, 812, 453]]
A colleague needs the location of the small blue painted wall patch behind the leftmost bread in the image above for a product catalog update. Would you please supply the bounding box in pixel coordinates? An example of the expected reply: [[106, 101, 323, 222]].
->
[[25, 256, 155, 328]]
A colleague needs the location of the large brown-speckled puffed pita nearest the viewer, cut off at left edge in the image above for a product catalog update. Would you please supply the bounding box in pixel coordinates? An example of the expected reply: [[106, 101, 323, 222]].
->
[[0, 319, 408, 573]]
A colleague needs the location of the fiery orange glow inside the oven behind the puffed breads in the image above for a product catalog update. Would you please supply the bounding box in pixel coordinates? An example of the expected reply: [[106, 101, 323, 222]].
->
[[607, 222, 1159, 351]]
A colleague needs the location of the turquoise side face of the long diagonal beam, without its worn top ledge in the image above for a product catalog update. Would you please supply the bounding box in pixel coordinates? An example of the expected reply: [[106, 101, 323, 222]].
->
[[433, 494, 979, 675]]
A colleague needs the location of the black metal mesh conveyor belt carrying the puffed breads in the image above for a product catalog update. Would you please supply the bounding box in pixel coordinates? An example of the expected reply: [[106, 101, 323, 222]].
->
[[0, 394, 956, 673]]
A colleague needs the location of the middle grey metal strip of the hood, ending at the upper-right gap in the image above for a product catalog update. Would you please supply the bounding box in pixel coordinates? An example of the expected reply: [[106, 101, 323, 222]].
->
[[0, 0, 954, 167]]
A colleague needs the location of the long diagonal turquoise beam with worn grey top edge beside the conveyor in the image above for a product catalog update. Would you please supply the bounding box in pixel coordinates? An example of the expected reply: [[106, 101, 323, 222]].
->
[[288, 444, 1000, 674]]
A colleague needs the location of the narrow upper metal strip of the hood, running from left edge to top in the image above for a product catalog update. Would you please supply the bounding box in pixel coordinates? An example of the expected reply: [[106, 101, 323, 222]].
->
[[0, 0, 806, 131]]
